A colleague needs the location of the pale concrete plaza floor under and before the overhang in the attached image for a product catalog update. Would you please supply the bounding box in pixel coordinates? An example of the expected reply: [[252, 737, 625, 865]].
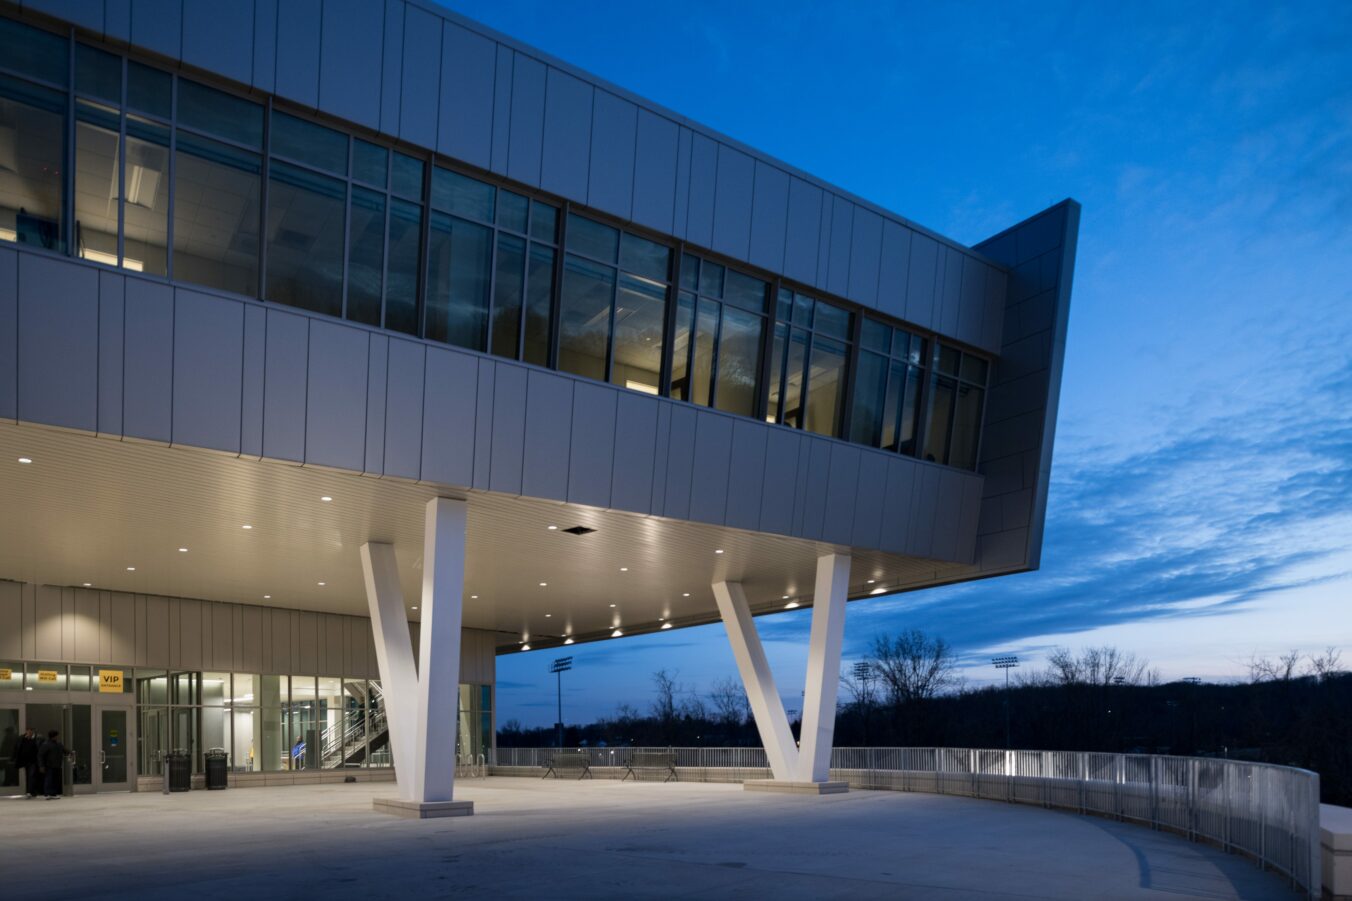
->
[[0, 777, 1297, 901]]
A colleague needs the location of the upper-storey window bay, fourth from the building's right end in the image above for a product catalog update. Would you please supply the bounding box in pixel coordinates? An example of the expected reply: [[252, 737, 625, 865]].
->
[[672, 254, 768, 417]]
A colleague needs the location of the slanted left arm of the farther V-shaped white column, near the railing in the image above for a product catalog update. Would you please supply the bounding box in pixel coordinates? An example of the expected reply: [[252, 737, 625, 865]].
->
[[714, 582, 798, 782]]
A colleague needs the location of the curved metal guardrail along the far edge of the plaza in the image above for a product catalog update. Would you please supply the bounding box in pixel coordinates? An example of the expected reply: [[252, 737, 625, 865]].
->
[[492, 748, 1321, 898]]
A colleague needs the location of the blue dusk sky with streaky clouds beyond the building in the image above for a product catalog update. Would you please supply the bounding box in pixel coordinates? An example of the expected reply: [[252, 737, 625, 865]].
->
[[446, 0, 1352, 725]]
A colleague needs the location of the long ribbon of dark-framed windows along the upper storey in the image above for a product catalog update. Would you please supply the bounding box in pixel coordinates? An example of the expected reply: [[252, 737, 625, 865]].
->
[[0, 16, 987, 470]]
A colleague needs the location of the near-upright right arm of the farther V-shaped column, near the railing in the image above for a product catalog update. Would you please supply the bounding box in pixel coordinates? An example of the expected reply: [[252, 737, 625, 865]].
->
[[796, 553, 850, 782]]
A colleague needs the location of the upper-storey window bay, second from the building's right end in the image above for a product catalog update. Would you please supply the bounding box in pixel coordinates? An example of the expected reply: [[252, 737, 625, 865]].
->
[[849, 318, 926, 456]]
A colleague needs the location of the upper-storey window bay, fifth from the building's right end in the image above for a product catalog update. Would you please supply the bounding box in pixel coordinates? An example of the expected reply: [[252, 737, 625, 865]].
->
[[558, 215, 671, 394]]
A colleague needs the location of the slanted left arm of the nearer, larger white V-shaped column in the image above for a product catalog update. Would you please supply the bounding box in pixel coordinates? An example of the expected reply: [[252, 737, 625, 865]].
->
[[361, 541, 418, 801]]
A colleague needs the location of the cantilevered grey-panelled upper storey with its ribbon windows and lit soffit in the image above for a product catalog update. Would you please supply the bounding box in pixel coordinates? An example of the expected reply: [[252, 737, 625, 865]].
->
[[0, 0, 1078, 646]]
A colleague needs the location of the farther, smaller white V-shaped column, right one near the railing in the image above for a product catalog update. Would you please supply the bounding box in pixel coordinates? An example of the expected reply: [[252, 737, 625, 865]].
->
[[713, 553, 850, 782]]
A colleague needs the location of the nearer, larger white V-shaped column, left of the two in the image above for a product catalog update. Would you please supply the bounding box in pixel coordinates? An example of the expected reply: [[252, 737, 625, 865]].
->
[[361, 498, 465, 804]]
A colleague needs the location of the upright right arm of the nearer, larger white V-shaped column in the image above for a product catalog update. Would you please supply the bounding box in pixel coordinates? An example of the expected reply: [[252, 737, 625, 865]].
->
[[408, 498, 466, 802]]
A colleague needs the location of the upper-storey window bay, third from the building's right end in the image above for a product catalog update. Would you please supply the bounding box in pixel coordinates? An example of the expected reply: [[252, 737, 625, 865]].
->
[[765, 288, 850, 436]]
